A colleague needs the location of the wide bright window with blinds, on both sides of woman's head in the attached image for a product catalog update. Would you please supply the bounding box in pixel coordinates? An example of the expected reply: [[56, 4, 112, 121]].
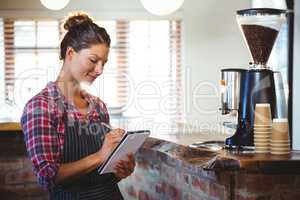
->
[[0, 19, 182, 131]]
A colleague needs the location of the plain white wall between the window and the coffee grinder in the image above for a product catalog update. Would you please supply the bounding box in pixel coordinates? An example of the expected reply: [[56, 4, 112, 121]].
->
[[183, 0, 250, 133]]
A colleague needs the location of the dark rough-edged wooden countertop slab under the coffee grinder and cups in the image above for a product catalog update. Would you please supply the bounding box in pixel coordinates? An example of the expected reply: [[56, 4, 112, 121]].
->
[[143, 137, 300, 174]]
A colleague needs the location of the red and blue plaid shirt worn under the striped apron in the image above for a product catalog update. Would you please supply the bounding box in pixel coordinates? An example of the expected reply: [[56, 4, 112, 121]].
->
[[21, 82, 109, 188]]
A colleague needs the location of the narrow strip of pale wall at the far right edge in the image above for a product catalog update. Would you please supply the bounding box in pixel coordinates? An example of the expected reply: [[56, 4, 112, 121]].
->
[[293, 1, 300, 150]]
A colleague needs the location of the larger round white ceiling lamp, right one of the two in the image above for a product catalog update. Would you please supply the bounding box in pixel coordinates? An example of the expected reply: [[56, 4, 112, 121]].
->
[[140, 0, 184, 15]]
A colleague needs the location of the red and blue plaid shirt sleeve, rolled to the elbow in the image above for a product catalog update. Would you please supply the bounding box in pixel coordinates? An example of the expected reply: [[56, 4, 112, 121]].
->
[[21, 96, 60, 189]]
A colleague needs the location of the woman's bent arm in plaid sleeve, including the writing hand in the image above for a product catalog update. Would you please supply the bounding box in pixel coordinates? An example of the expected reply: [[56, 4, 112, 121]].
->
[[21, 97, 124, 188]]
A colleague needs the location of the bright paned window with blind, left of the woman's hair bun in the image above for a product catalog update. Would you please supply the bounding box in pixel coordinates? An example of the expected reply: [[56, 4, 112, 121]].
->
[[4, 19, 59, 106]]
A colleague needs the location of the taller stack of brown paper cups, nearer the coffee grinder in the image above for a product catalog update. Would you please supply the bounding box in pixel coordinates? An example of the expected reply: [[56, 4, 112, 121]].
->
[[254, 104, 272, 153]]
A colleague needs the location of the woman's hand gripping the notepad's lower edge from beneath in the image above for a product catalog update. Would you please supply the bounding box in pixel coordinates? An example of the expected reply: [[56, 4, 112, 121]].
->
[[115, 154, 135, 179]]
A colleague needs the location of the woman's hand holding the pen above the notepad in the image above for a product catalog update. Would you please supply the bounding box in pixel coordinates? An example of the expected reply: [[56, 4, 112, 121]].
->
[[98, 128, 125, 161]]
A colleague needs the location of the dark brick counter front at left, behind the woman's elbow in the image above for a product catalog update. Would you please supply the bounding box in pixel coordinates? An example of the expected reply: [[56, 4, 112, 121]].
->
[[0, 132, 48, 200]]
